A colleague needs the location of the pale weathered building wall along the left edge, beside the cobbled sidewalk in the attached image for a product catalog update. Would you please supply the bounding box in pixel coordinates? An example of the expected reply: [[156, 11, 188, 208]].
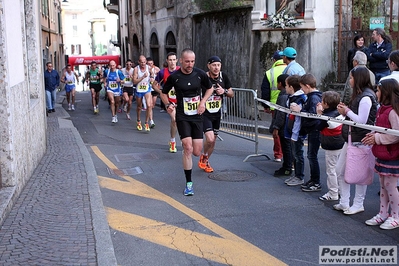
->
[[0, 0, 46, 224]]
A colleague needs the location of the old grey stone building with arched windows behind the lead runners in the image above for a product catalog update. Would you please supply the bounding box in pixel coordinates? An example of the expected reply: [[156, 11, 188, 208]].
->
[[105, 0, 336, 90]]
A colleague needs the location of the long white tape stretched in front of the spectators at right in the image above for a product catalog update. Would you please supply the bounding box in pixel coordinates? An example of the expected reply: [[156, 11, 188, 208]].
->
[[256, 98, 399, 137]]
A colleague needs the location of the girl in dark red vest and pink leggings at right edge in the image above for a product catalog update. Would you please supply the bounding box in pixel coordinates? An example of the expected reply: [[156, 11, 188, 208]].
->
[[362, 79, 399, 229]]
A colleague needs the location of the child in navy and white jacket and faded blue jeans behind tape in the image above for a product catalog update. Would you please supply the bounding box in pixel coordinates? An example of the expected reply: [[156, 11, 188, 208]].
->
[[284, 75, 306, 186]]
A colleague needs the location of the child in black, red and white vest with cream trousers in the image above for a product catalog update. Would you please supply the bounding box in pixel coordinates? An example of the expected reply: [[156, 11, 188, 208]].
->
[[317, 91, 345, 201]]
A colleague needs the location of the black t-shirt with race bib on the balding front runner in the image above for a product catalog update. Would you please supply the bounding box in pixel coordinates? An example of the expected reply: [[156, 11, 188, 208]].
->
[[162, 68, 212, 121]]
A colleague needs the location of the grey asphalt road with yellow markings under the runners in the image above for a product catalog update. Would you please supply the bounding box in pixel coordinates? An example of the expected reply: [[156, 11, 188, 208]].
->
[[64, 92, 399, 265]]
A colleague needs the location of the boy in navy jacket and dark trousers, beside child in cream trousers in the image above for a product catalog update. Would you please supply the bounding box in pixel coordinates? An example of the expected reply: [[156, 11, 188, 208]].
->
[[291, 74, 321, 192]]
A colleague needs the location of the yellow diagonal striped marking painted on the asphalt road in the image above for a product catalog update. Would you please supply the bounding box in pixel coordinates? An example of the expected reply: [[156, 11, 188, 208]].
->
[[91, 146, 286, 265]]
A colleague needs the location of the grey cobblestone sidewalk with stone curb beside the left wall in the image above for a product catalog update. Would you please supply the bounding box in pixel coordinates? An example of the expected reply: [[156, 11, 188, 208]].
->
[[0, 107, 116, 266]]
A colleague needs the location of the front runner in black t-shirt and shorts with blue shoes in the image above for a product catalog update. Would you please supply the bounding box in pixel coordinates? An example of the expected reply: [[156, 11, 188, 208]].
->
[[161, 49, 213, 196]]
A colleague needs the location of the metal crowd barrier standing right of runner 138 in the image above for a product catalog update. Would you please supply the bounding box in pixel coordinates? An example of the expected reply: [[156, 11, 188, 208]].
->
[[220, 88, 270, 162]]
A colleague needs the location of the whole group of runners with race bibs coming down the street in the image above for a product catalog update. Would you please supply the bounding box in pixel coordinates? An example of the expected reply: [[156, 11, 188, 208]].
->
[[80, 49, 234, 196]]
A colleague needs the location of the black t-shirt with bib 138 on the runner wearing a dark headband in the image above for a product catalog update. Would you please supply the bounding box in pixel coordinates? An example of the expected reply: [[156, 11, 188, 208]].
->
[[202, 71, 231, 117]]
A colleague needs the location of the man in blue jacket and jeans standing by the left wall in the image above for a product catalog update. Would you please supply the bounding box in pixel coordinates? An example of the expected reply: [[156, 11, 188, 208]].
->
[[44, 62, 60, 113]]
